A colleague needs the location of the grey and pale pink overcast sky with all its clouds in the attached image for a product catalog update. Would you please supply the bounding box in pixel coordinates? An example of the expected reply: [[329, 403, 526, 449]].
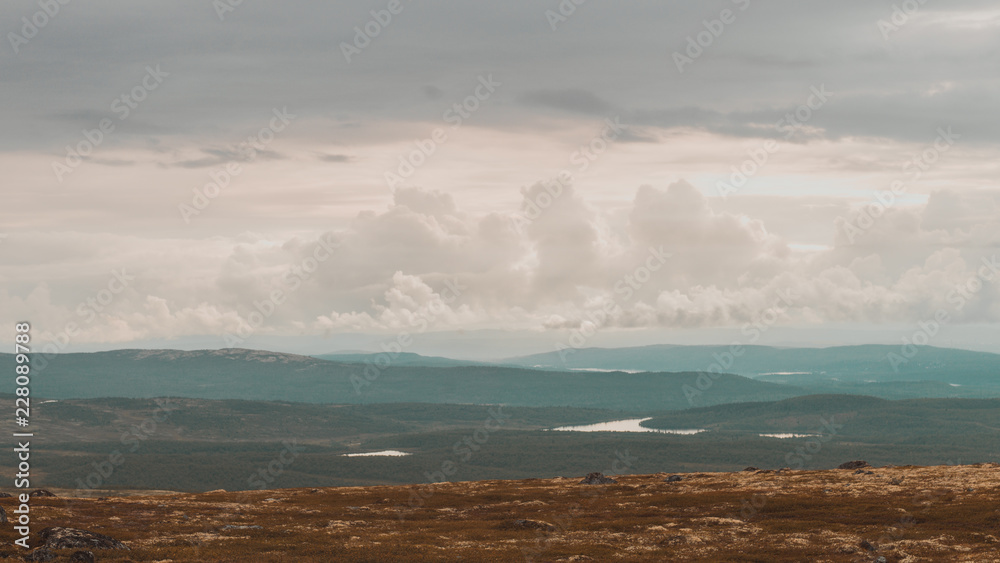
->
[[0, 0, 1000, 357]]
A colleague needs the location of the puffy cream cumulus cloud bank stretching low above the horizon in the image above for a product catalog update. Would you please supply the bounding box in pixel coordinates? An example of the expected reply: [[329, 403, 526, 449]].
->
[[0, 181, 1000, 348]]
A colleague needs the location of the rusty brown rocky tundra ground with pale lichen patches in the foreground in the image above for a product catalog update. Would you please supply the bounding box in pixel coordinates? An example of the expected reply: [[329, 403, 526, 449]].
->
[[0, 464, 1000, 563]]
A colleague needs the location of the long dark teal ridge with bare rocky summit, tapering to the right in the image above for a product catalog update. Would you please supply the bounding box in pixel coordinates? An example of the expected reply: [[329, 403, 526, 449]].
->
[[0, 349, 809, 411]]
